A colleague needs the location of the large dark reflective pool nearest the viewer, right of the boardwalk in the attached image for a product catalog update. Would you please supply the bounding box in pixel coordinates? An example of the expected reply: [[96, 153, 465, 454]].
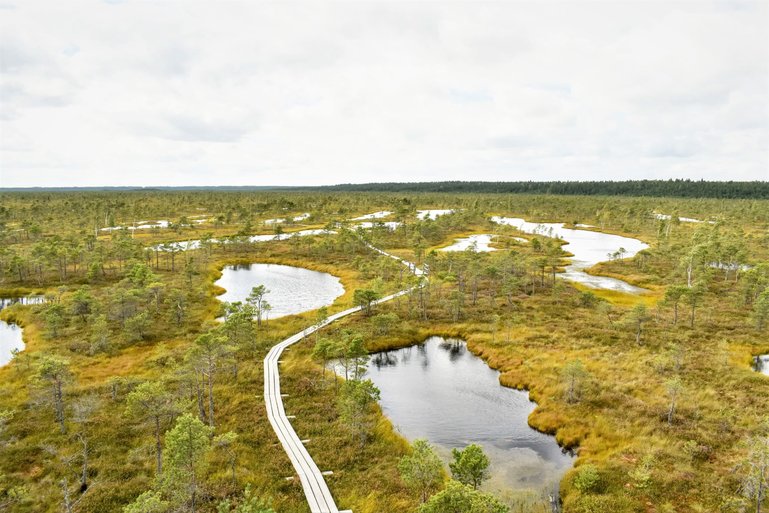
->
[[366, 337, 574, 495]]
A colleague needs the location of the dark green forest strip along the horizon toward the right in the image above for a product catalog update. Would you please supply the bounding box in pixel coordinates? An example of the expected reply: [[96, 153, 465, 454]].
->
[[312, 180, 769, 199]]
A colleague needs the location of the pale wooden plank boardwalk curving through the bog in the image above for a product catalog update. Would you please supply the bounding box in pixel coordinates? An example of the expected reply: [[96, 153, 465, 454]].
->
[[264, 244, 424, 513]]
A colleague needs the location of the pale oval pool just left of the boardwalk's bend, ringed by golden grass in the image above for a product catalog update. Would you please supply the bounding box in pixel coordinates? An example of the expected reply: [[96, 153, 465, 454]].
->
[[216, 264, 344, 319]]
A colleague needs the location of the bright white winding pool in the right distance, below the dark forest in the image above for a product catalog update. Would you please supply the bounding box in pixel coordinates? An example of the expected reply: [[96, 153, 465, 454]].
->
[[491, 216, 649, 294]]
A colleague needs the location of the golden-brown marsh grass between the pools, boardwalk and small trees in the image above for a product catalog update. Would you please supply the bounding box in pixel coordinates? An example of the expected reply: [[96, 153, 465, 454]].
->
[[0, 193, 769, 513]]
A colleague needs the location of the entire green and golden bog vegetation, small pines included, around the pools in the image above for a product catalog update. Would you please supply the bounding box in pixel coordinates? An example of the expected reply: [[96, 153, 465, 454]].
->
[[0, 190, 769, 513]]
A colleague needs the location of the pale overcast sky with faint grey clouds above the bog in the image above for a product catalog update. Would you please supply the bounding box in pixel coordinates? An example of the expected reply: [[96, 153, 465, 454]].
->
[[0, 0, 769, 187]]
